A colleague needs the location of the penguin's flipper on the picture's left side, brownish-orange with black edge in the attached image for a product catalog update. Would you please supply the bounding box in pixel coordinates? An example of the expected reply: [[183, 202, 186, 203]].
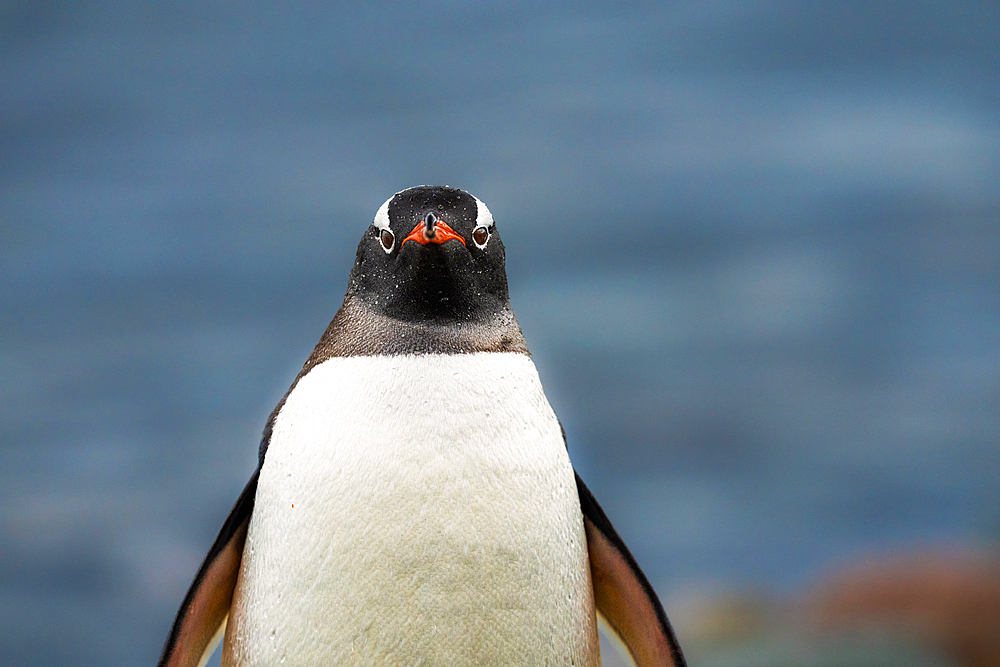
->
[[157, 468, 260, 667]]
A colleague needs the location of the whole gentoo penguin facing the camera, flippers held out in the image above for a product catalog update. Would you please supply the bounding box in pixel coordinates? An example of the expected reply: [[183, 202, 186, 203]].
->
[[159, 187, 684, 667]]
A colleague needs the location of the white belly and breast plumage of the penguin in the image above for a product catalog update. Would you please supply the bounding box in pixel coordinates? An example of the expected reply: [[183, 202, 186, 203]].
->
[[223, 353, 600, 666]]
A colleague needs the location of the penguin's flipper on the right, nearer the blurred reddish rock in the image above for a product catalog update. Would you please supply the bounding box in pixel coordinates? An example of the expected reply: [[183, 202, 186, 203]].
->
[[576, 475, 685, 667]]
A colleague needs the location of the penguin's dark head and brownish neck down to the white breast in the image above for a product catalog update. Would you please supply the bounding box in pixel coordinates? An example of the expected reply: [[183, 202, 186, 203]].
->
[[260, 186, 528, 462]]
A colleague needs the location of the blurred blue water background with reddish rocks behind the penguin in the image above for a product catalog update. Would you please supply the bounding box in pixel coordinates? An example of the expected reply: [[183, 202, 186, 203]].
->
[[0, 0, 1000, 667]]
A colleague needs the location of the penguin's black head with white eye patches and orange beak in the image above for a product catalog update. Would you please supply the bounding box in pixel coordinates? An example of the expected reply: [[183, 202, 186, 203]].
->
[[347, 186, 510, 322]]
